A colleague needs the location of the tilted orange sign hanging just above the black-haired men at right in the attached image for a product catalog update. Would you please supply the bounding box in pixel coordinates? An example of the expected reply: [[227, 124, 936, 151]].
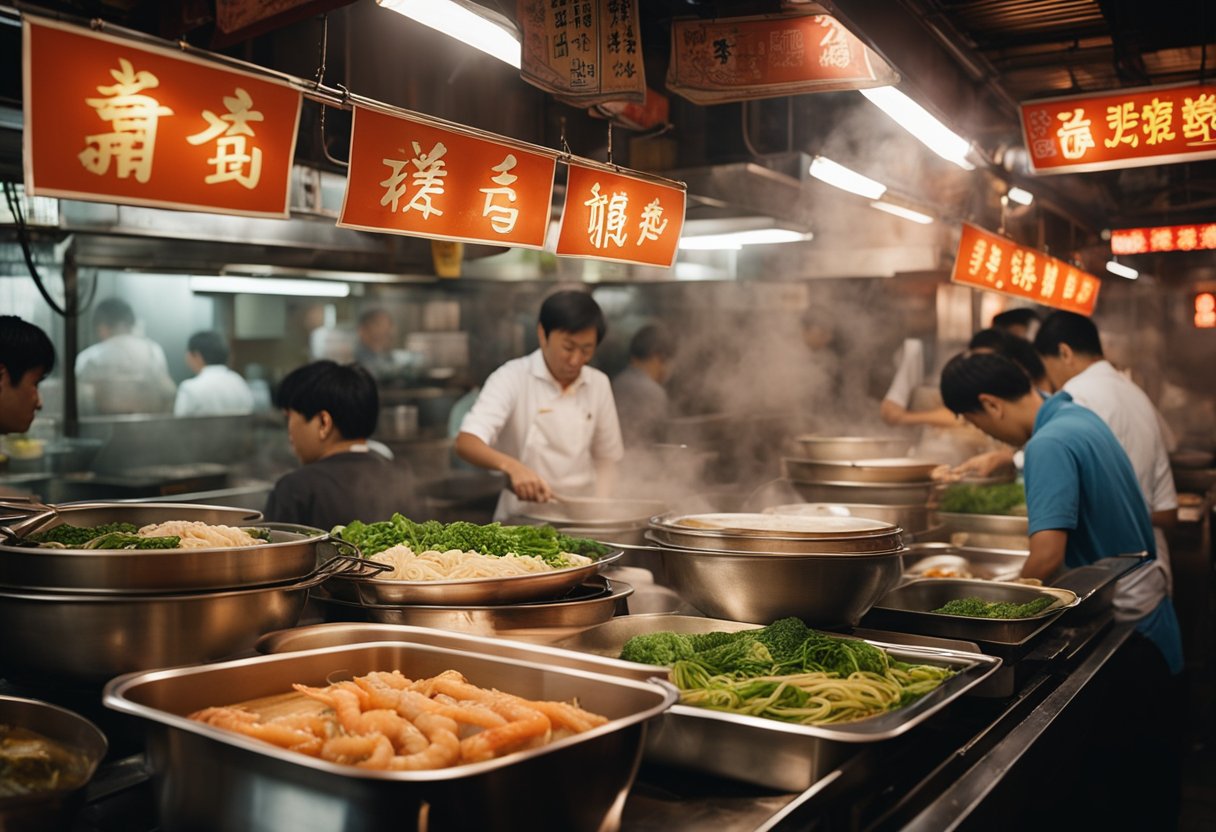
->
[[950, 223, 1102, 315]]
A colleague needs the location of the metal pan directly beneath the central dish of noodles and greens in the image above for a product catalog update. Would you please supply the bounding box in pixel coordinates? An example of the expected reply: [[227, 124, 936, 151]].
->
[[317, 575, 634, 641]]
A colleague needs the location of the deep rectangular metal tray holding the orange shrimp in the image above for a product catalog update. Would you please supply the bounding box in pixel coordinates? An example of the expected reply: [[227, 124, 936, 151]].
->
[[103, 642, 676, 832]]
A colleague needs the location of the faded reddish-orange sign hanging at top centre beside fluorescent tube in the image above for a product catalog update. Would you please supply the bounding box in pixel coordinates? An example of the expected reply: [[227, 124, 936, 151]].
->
[[668, 15, 899, 103]]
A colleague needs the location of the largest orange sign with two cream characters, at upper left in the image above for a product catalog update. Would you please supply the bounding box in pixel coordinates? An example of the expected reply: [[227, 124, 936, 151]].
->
[[23, 16, 300, 218]]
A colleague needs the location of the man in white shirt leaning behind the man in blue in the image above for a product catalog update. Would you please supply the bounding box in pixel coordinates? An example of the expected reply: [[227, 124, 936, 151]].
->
[[1035, 311, 1178, 608]]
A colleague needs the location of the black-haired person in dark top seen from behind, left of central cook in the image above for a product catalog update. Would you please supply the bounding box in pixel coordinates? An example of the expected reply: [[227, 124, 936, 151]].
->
[[265, 361, 417, 529]]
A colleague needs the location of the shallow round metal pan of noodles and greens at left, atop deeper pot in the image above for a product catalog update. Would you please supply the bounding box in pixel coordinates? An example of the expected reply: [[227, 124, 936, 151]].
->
[[0, 502, 335, 594]]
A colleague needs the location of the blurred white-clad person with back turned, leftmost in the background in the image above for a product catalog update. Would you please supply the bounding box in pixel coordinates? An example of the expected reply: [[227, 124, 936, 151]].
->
[[75, 298, 178, 415]]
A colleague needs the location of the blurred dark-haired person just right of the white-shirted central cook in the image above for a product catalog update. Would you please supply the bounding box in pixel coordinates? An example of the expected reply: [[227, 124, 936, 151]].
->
[[612, 324, 676, 448]]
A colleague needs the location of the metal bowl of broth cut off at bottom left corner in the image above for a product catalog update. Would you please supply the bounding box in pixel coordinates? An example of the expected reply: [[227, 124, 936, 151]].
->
[[0, 696, 107, 832]]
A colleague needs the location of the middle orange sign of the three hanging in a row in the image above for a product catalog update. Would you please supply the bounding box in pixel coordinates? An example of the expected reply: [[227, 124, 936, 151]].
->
[[338, 107, 557, 248]]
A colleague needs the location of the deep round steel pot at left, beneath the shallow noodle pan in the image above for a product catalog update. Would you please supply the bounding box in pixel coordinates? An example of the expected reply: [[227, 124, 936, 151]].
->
[[0, 557, 376, 682]]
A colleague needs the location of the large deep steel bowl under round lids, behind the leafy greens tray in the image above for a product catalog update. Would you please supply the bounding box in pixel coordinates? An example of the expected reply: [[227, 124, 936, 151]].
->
[[662, 546, 902, 626]]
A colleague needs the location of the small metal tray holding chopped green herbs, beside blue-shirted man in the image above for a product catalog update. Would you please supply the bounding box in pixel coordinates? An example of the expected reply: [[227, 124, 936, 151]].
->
[[862, 578, 1079, 647]]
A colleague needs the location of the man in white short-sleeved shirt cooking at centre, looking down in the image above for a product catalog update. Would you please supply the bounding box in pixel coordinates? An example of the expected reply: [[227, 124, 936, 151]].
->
[[456, 291, 624, 519]]
